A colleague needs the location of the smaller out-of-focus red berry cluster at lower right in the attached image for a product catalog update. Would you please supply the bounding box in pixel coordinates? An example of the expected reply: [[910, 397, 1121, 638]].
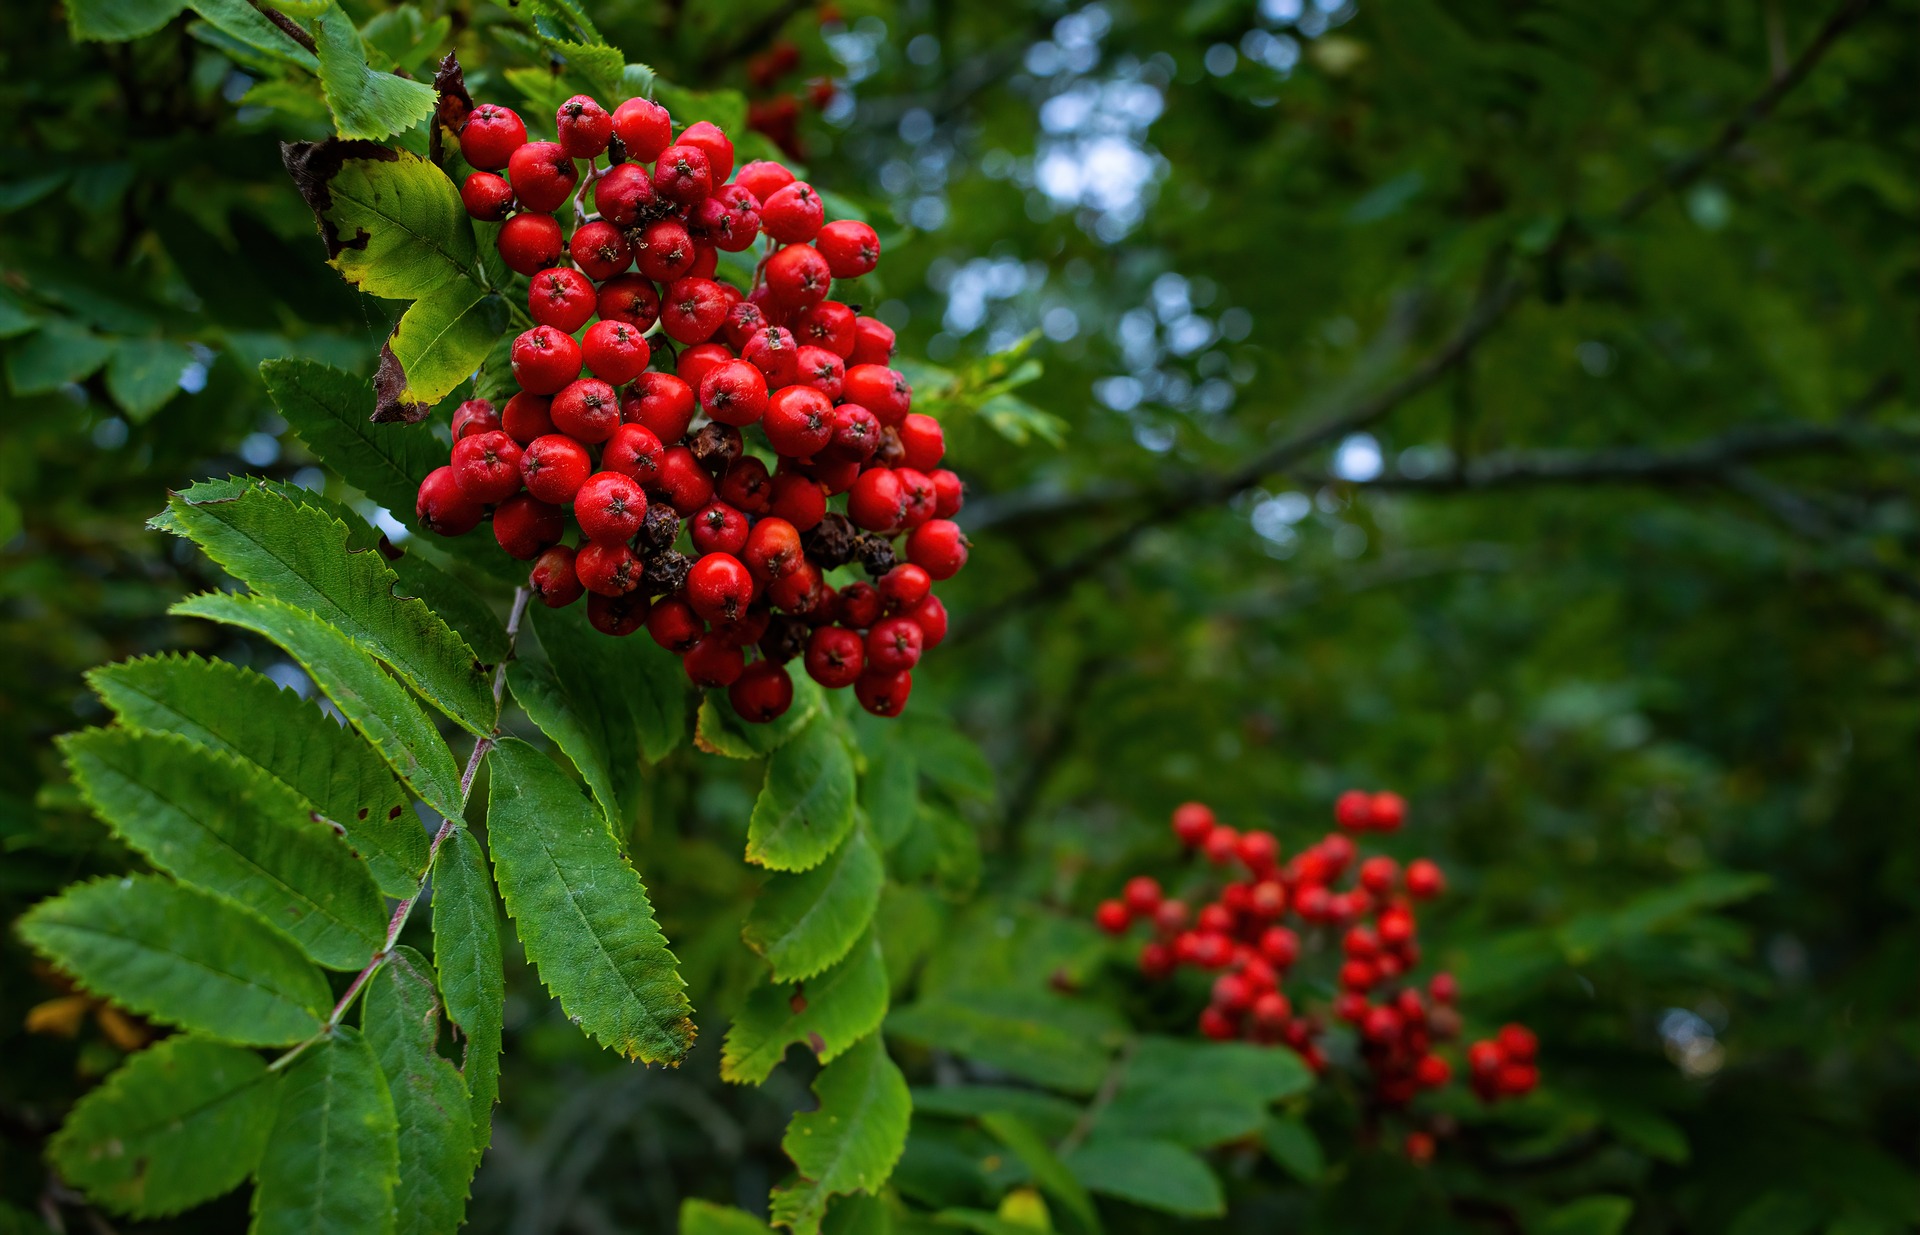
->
[[1094, 791, 1538, 1129]]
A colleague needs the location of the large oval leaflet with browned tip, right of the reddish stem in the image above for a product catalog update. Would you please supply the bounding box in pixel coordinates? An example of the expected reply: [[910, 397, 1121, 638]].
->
[[488, 741, 693, 1064]]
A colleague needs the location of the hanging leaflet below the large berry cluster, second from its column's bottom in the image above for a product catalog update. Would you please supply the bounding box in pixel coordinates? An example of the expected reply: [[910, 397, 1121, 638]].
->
[[720, 933, 887, 1085]]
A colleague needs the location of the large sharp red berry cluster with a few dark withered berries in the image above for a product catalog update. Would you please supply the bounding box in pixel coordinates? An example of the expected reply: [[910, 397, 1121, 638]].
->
[[417, 96, 968, 722]]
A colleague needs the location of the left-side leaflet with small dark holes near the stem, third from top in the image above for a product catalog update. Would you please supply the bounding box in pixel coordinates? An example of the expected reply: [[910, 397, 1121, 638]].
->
[[86, 655, 426, 897]]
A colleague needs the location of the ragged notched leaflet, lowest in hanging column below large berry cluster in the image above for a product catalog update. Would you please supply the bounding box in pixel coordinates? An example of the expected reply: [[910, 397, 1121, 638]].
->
[[772, 1033, 914, 1235]]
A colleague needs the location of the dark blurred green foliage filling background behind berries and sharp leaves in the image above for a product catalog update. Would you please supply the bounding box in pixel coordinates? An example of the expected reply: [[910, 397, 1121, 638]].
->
[[0, 0, 1920, 1235]]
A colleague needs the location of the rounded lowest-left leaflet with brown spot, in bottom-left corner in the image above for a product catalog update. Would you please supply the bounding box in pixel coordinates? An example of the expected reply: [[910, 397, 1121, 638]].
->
[[48, 1035, 278, 1218]]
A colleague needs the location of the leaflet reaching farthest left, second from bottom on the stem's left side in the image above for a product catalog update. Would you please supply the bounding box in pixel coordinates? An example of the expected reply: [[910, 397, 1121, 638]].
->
[[19, 874, 332, 1047]]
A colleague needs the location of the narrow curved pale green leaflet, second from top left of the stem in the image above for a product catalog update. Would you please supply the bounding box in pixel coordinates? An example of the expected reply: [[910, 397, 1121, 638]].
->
[[167, 592, 461, 816]]
